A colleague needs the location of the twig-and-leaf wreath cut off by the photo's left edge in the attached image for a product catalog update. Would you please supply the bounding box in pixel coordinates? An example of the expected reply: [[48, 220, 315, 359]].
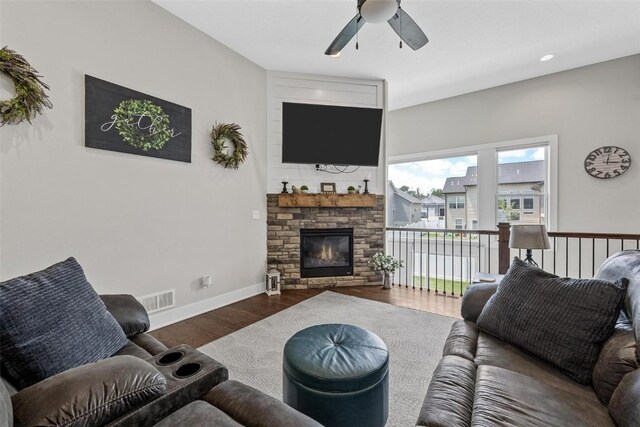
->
[[0, 46, 53, 126]]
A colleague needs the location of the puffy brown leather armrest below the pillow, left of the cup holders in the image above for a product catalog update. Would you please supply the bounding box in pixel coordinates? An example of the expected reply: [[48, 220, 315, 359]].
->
[[11, 356, 167, 427]]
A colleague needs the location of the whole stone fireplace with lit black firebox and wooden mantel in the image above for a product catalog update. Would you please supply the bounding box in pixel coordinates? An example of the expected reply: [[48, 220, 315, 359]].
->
[[267, 194, 385, 289]]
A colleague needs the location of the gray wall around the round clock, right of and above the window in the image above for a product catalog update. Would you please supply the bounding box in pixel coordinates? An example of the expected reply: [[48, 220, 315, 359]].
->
[[387, 55, 640, 233]]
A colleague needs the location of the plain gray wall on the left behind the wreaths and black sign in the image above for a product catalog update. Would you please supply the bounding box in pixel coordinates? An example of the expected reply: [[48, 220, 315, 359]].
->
[[0, 1, 266, 314]]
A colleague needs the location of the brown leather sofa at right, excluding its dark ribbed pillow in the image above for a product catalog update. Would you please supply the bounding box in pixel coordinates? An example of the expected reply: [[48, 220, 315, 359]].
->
[[417, 251, 640, 426]]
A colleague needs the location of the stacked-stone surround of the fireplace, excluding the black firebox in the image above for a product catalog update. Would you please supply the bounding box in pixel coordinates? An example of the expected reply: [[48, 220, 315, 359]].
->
[[267, 194, 385, 289]]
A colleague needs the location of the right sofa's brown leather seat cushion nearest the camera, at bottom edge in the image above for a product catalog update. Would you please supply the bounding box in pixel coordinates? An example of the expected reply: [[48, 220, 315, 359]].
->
[[471, 365, 615, 427]]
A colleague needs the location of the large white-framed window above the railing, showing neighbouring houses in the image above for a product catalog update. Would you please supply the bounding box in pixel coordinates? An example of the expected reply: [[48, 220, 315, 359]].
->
[[387, 135, 558, 231]]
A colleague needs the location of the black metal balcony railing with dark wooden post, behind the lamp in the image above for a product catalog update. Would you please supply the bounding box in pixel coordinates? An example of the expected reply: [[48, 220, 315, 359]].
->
[[386, 223, 640, 297]]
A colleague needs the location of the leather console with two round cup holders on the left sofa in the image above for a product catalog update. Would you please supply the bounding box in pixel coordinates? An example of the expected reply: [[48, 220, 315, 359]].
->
[[109, 345, 229, 427]]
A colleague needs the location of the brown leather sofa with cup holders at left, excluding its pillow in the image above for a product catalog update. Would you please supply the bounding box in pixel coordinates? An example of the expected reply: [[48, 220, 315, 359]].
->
[[0, 295, 321, 427]]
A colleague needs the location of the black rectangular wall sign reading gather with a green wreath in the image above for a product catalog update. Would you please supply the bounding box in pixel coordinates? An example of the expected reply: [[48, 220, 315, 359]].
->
[[84, 75, 191, 163]]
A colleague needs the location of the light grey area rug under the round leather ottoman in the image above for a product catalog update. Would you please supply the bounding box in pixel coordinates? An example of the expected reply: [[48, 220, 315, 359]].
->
[[200, 291, 455, 427]]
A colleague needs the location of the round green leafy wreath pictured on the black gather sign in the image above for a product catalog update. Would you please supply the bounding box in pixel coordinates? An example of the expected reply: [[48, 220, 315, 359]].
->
[[113, 99, 171, 151]]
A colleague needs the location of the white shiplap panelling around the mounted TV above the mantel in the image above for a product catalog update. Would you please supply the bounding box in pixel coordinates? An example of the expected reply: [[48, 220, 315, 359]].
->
[[267, 71, 387, 194]]
